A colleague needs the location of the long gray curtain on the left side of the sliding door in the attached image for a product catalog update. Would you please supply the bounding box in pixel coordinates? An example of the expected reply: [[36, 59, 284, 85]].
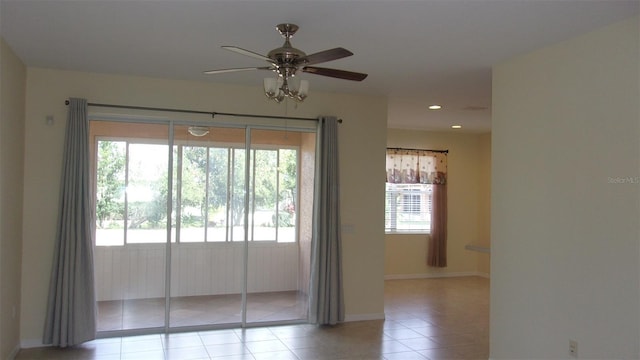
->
[[43, 99, 97, 347]]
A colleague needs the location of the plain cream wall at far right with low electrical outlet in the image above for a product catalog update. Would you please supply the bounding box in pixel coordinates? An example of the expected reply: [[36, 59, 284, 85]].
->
[[491, 17, 640, 359]]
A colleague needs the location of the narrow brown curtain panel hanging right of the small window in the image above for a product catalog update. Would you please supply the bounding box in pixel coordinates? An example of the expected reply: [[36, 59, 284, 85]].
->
[[427, 184, 447, 267]]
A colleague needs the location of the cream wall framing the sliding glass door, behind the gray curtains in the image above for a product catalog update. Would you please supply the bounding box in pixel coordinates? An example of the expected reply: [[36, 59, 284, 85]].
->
[[21, 68, 387, 346]]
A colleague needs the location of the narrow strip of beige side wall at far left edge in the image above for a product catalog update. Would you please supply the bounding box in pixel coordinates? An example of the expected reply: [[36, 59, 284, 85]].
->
[[0, 38, 26, 359]]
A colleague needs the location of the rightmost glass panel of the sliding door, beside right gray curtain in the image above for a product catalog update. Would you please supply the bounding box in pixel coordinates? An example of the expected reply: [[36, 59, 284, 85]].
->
[[246, 130, 315, 323]]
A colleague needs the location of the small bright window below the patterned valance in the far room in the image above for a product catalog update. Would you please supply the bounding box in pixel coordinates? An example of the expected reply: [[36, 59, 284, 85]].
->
[[385, 183, 433, 232]]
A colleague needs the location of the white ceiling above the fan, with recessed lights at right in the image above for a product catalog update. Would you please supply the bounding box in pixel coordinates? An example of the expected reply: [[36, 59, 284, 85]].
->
[[0, 0, 639, 132]]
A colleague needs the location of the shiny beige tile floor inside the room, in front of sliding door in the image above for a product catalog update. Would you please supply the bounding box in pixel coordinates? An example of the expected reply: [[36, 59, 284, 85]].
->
[[16, 277, 489, 360]]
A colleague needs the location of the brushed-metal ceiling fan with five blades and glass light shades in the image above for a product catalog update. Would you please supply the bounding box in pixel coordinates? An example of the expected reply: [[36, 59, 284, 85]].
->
[[204, 23, 367, 102]]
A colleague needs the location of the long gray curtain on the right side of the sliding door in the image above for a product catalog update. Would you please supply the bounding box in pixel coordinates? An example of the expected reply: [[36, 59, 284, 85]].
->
[[309, 117, 344, 325]]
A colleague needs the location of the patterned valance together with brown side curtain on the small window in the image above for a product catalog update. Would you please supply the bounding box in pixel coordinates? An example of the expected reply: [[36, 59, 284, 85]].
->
[[387, 149, 447, 267]]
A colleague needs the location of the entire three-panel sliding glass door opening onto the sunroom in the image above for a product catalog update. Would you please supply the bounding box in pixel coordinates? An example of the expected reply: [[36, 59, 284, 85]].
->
[[91, 121, 315, 332]]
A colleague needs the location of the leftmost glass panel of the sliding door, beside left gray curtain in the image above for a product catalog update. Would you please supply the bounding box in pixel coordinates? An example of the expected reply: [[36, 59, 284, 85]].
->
[[91, 122, 170, 331]]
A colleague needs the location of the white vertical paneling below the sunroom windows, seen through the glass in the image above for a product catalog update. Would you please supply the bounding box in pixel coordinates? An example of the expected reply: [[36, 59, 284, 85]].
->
[[95, 243, 299, 301]]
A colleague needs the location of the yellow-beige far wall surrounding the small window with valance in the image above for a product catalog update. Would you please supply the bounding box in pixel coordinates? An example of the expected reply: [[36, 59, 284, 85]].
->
[[385, 129, 491, 279]]
